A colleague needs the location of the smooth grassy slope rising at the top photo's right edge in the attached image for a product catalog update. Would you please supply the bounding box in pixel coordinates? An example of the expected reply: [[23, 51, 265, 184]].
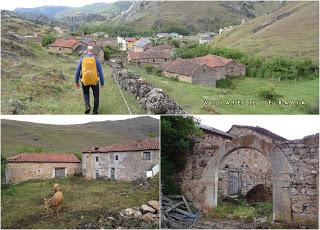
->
[[214, 2, 319, 63]]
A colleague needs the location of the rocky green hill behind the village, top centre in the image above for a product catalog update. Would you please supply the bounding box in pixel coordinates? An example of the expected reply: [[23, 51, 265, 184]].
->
[[104, 1, 282, 32]]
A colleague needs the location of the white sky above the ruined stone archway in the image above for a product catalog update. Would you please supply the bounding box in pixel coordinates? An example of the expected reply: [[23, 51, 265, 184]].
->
[[195, 115, 320, 140]]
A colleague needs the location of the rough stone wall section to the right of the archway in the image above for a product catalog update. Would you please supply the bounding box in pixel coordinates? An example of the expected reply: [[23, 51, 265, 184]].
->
[[276, 134, 319, 222]]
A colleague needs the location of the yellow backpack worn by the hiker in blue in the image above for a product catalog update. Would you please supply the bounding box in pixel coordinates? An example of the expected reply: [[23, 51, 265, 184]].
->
[[81, 57, 99, 86]]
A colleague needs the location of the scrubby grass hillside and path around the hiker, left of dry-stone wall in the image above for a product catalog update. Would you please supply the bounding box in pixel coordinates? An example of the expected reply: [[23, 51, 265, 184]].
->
[[1, 11, 145, 114]]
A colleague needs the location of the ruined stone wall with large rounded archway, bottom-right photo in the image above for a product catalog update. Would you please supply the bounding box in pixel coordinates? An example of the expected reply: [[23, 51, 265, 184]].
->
[[177, 127, 319, 223]]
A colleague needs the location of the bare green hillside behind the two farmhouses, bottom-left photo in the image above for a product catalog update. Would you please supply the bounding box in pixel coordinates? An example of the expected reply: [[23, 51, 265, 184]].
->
[[1, 117, 159, 157]]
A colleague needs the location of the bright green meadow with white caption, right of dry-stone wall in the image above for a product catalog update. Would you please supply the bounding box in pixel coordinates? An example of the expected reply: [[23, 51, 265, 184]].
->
[[128, 65, 319, 114]]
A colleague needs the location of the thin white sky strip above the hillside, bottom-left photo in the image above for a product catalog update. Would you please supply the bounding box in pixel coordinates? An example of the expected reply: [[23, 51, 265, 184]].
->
[[1, 115, 160, 125]]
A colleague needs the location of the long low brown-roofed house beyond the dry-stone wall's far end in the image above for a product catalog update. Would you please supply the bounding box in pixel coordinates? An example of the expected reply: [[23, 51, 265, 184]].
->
[[128, 49, 172, 65]]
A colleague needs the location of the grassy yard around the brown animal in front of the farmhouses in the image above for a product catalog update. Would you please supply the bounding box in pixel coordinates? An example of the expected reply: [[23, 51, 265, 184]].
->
[[1, 177, 159, 229]]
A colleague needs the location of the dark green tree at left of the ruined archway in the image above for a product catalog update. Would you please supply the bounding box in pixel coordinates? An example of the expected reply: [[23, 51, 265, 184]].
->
[[161, 116, 202, 194]]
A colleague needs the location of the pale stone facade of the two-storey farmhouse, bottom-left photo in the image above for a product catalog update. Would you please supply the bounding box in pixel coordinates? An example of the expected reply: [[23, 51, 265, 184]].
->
[[82, 150, 160, 181]]
